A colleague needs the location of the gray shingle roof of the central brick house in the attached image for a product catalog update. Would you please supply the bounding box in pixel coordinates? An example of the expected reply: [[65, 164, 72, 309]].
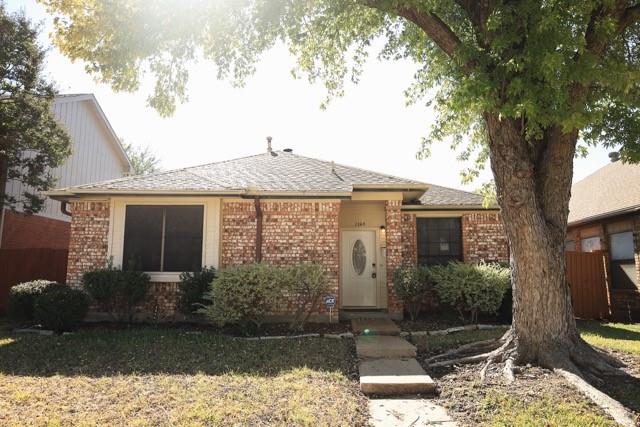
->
[[57, 151, 428, 193]]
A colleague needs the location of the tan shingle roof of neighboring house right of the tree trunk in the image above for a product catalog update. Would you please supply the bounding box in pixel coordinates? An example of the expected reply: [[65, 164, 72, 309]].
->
[[569, 161, 640, 224]]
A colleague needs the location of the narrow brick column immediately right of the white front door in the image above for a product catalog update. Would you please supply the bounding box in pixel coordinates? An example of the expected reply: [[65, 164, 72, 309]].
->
[[385, 200, 403, 317]]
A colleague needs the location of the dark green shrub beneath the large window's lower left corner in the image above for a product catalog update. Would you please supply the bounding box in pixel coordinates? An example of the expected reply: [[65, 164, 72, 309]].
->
[[82, 264, 149, 321]]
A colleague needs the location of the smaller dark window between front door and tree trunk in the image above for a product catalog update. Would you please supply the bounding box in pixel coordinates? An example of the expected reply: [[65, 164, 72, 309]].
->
[[416, 218, 463, 265]]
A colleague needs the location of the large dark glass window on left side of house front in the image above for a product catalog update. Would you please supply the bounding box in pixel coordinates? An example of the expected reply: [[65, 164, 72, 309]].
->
[[122, 205, 204, 272]]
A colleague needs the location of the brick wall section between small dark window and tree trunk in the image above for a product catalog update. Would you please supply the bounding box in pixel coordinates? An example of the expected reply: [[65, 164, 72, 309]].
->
[[462, 212, 509, 262]]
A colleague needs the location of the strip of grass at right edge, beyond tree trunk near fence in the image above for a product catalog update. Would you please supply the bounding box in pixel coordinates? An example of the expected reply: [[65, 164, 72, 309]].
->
[[578, 322, 640, 355]]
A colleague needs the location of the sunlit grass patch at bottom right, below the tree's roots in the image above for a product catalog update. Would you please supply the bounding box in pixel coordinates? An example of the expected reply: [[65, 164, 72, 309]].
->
[[480, 392, 617, 427]]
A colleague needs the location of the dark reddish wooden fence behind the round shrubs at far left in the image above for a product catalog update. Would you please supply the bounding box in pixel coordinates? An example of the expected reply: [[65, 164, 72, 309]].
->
[[0, 249, 68, 312]]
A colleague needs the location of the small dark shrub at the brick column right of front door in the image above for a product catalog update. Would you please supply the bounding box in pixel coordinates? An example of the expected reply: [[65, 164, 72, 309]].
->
[[393, 266, 433, 320]]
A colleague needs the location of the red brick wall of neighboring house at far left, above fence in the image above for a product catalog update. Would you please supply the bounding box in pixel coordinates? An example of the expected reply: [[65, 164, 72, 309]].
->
[[0, 209, 71, 249]]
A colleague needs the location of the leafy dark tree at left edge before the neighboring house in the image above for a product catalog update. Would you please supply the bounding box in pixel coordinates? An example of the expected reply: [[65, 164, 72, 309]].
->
[[0, 2, 70, 213]]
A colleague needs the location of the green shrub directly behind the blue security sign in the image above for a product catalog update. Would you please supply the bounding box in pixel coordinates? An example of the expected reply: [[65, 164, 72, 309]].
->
[[284, 264, 329, 331]]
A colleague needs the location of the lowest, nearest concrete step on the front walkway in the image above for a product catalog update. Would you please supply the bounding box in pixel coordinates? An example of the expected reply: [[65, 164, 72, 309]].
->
[[359, 358, 436, 395]]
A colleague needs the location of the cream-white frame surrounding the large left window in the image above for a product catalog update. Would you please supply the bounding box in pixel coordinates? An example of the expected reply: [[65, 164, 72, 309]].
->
[[108, 197, 221, 282]]
